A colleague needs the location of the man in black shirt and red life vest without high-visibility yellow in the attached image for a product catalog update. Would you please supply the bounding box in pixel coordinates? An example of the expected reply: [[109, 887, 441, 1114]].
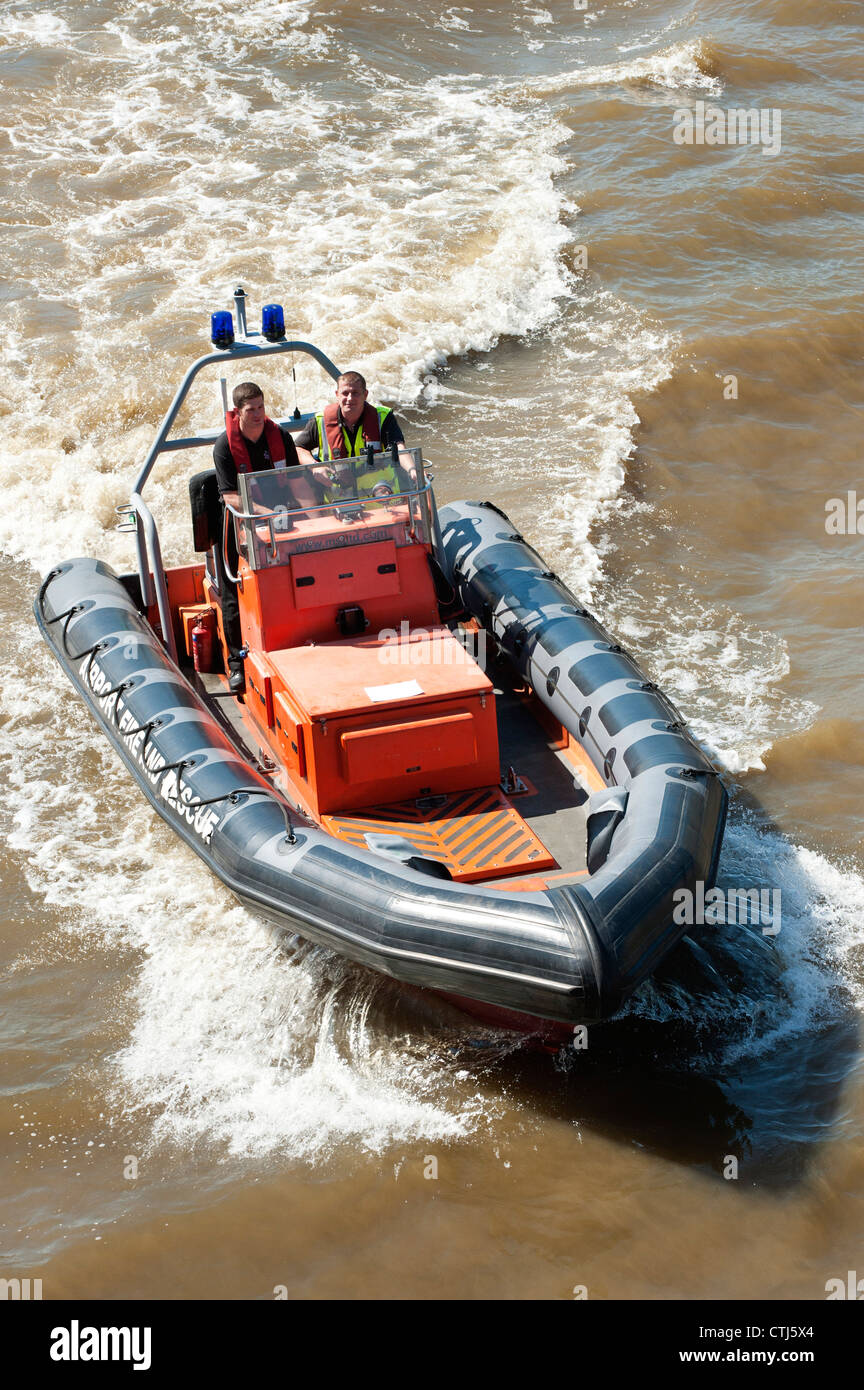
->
[[213, 381, 317, 695]]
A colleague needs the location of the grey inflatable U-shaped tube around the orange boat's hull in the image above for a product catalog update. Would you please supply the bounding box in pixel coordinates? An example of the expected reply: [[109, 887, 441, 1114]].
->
[[35, 502, 726, 1023]]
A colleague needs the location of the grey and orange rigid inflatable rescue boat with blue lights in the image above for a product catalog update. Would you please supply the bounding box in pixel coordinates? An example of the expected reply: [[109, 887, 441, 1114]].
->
[[35, 297, 726, 1033]]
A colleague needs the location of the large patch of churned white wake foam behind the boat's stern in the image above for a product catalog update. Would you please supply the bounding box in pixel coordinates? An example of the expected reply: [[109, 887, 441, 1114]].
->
[[0, 44, 583, 569]]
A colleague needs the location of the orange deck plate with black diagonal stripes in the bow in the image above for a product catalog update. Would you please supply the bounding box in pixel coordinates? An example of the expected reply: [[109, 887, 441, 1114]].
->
[[322, 787, 556, 883]]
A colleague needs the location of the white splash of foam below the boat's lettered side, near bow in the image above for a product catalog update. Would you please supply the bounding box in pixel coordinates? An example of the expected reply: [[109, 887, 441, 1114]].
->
[[117, 906, 485, 1161]]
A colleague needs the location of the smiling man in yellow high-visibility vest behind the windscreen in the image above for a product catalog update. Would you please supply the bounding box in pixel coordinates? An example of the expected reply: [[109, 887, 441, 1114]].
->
[[294, 371, 415, 502]]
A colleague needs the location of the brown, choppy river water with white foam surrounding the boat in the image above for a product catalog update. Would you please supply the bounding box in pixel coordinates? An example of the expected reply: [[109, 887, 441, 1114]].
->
[[0, 0, 864, 1300]]
